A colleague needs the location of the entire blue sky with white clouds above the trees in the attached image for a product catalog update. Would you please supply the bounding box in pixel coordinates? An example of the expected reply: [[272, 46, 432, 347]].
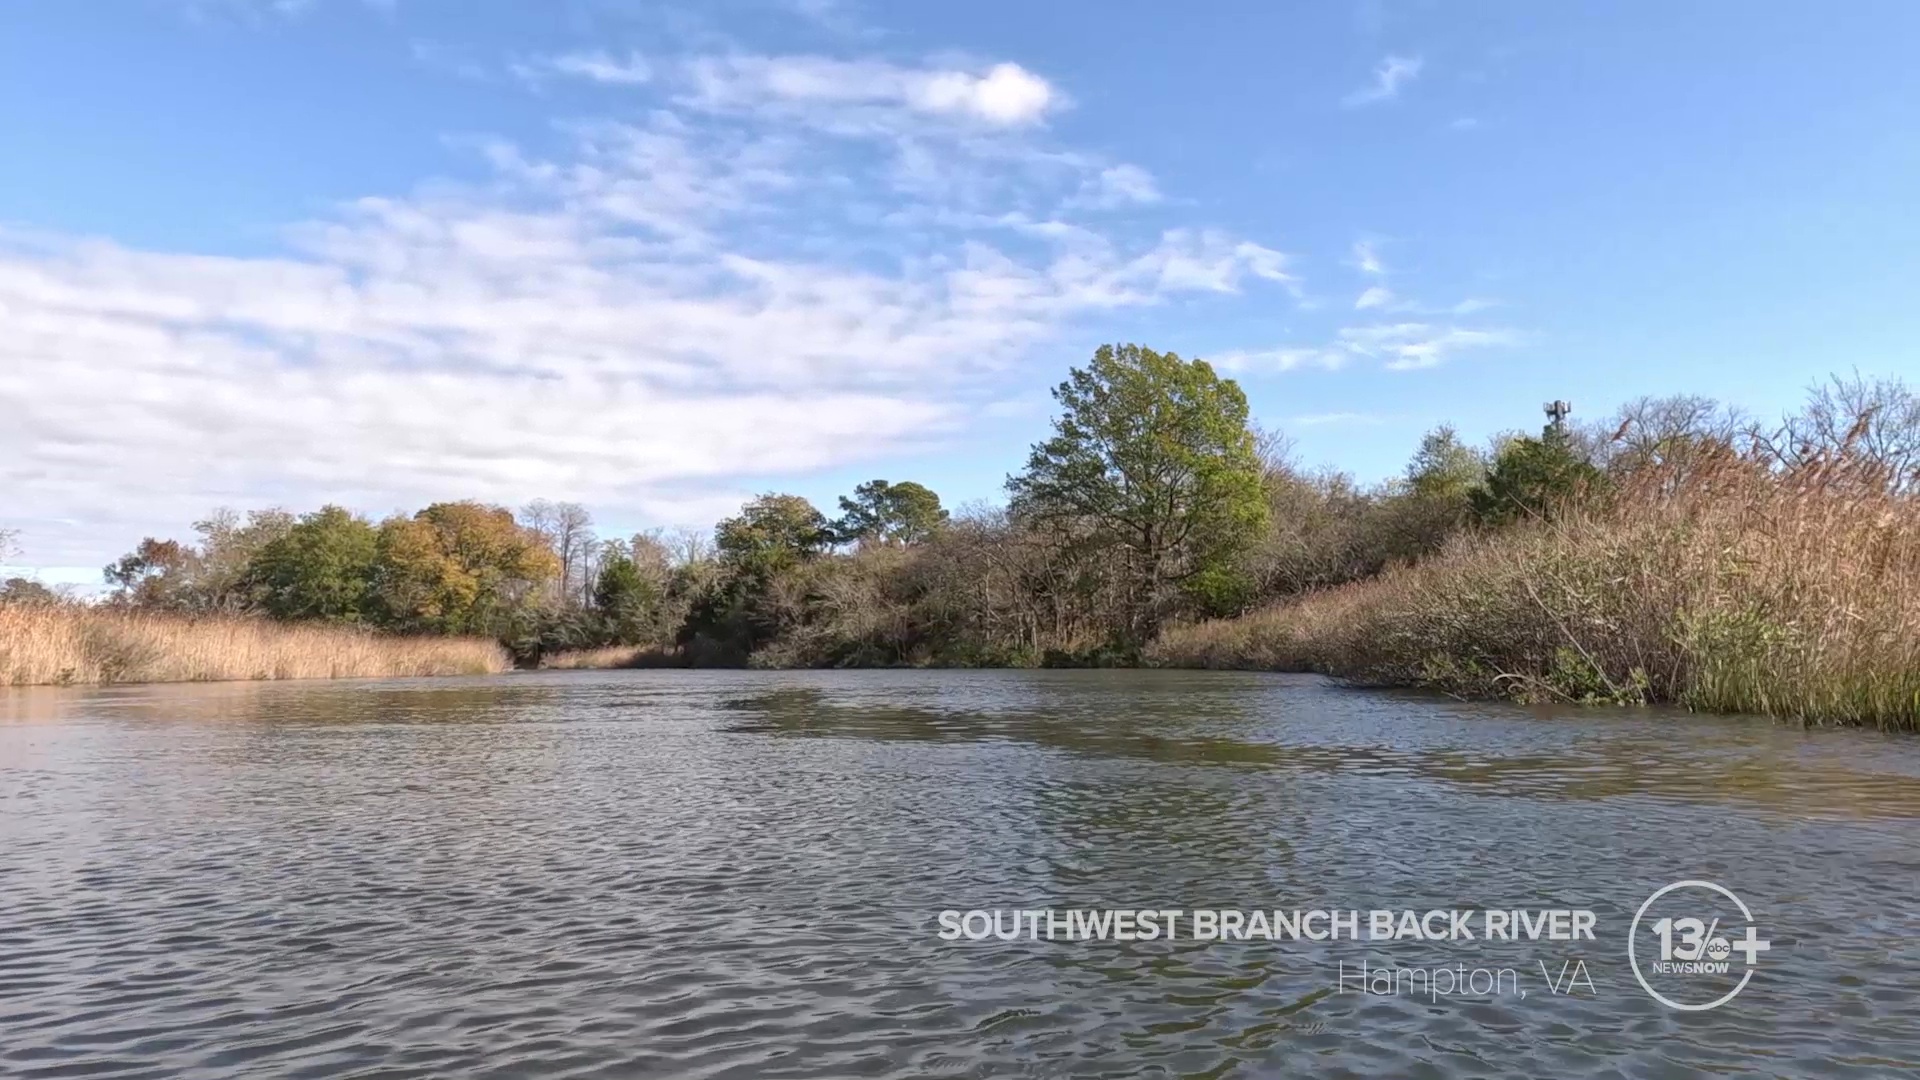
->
[[0, 0, 1920, 580]]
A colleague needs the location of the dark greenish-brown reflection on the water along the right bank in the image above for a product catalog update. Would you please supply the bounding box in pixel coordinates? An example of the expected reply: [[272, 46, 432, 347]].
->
[[720, 678, 1920, 817]]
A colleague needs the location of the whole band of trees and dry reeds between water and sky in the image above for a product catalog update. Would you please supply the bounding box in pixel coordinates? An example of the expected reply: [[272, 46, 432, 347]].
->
[[0, 355, 1920, 728]]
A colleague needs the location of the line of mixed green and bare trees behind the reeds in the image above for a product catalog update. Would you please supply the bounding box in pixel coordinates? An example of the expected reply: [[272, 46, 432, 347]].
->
[[0, 344, 1920, 665]]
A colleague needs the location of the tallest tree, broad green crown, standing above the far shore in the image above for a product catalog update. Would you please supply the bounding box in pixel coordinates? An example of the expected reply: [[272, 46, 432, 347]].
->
[[1008, 344, 1267, 642]]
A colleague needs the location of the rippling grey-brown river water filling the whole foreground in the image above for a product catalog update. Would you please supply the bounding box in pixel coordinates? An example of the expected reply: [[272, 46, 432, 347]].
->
[[0, 673, 1920, 1078]]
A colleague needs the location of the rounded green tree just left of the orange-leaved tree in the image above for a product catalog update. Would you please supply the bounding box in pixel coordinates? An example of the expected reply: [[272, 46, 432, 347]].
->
[[248, 505, 380, 623]]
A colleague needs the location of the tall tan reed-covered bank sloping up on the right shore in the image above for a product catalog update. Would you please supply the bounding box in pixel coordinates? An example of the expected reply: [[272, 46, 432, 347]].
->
[[1148, 449, 1920, 730]]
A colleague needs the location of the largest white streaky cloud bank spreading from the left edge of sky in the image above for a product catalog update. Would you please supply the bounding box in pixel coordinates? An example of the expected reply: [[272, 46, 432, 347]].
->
[[0, 54, 1292, 565]]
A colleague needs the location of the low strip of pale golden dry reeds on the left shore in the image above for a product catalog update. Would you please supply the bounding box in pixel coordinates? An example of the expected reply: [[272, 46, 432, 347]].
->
[[0, 603, 511, 686]]
